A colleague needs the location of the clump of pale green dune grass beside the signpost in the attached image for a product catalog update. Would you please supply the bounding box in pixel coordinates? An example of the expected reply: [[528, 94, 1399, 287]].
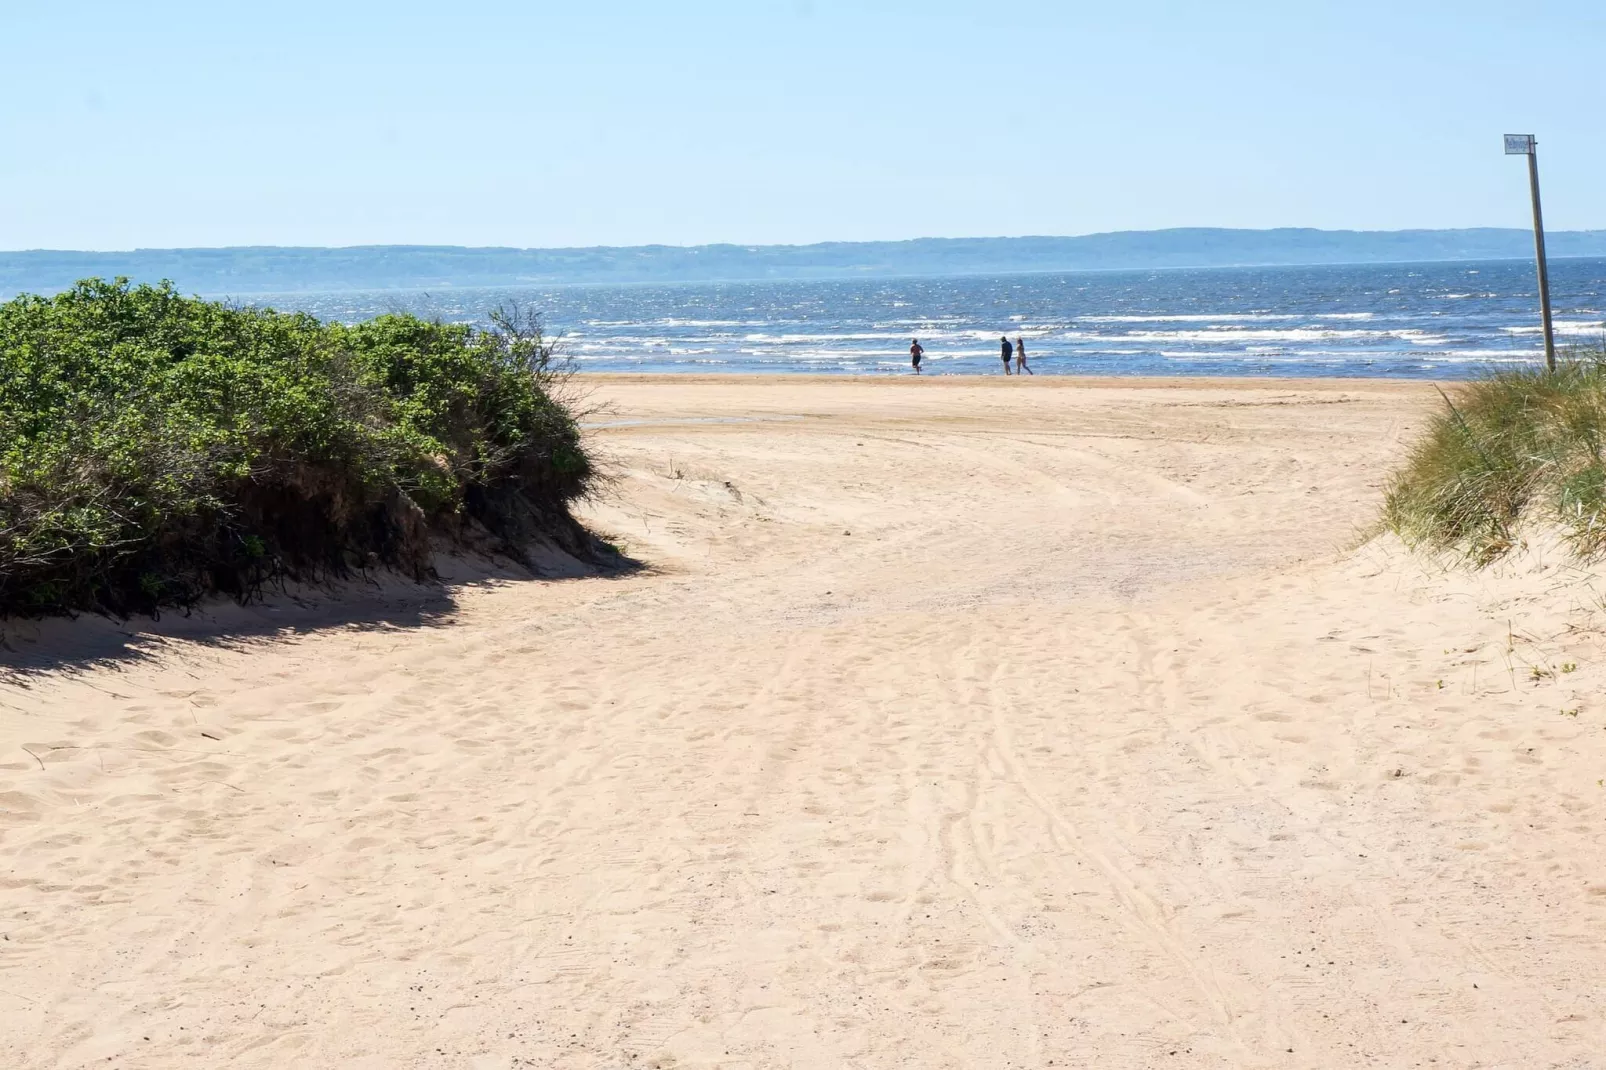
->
[[1384, 352, 1606, 564]]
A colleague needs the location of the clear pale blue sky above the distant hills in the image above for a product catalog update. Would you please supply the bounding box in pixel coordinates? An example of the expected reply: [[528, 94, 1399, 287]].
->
[[0, 0, 1606, 249]]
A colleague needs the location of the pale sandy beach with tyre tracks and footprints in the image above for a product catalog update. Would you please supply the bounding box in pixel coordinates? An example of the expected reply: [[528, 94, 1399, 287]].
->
[[0, 376, 1606, 1070]]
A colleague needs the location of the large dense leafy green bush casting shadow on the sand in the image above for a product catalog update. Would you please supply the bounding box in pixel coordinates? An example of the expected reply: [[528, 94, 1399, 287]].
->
[[0, 280, 593, 615]]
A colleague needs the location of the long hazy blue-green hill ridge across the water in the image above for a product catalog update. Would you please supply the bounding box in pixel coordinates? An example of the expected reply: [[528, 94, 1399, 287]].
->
[[0, 227, 1606, 296]]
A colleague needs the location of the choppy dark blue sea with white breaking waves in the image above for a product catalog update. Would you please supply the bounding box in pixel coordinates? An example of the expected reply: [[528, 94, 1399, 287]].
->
[[246, 259, 1606, 379]]
